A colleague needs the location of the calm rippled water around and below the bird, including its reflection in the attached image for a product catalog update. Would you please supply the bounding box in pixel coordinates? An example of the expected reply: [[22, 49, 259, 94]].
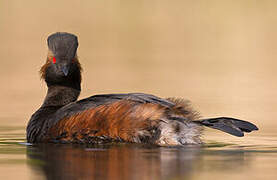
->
[[0, 126, 277, 180]]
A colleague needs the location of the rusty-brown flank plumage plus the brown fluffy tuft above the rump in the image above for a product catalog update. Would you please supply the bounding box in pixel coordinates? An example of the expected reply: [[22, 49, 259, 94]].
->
[[45, 99, 201, 143]]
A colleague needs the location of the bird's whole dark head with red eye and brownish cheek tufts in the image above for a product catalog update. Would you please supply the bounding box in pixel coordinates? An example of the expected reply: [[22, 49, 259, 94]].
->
[[40, 32, 81, 89]]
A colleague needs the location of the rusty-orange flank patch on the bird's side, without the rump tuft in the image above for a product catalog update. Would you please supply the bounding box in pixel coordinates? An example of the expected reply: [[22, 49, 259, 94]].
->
[[46, 100, 164, 142]]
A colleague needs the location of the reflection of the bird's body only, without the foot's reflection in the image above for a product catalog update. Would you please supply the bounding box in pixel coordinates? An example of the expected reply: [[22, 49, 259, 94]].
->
[[27, 144, 200, 180]]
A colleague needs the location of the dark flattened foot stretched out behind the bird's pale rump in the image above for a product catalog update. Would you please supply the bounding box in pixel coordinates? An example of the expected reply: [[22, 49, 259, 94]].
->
[[194, 117, 258, 137]]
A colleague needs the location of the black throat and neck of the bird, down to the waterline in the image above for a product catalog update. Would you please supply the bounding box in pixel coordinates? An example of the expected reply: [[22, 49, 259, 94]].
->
[[27, 62, 81, 143]]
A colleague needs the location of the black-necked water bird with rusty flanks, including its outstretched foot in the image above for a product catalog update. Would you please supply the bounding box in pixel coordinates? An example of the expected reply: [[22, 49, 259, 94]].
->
[[26, 32, 258, 146]]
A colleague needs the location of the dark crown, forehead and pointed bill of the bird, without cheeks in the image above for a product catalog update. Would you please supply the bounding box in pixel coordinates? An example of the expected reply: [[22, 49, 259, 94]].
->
[[47, 32, 78, 76]]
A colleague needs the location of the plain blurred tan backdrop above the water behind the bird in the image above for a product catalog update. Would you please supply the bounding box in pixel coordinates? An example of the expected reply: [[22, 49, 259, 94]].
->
[[0, 0, 277, 179]]
